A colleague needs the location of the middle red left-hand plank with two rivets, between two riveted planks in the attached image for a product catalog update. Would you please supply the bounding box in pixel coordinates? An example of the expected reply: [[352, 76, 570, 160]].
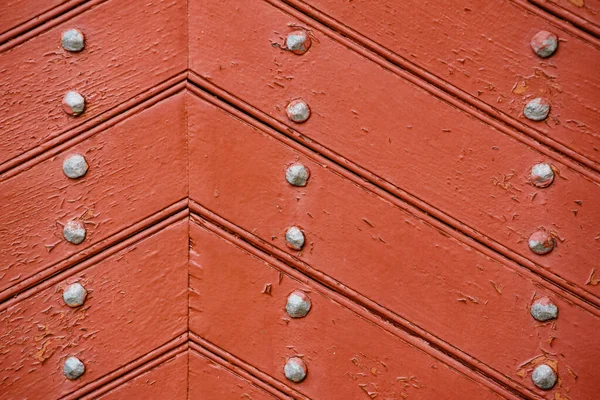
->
[[0, 95, 187, 289]]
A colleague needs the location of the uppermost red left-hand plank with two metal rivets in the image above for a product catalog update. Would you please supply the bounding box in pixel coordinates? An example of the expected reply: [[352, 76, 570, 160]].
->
[[0, 1, 187, 163]]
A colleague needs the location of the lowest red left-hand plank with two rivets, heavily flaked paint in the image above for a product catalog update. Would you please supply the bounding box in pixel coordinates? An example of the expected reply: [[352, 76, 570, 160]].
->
[[0, 221, 188, 399]]
